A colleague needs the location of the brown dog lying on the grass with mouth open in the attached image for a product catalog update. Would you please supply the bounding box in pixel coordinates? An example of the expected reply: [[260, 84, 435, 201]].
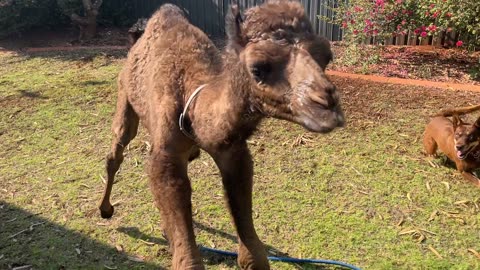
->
[[423, 114, 480, 187]]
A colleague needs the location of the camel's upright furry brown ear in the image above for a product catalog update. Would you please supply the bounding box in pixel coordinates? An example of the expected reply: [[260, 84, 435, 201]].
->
[[225, 1, 245, 53]]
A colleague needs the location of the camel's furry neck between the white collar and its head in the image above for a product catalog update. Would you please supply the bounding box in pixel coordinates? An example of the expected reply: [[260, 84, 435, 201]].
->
[[189, 52, 262, 148]]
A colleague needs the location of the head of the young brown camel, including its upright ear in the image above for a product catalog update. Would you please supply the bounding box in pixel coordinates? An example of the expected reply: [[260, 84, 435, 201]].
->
[[226, 1, 344, 132]]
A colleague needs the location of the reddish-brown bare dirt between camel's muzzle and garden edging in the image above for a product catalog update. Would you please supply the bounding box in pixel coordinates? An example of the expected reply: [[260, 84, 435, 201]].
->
[[330, 75, 480, 127]]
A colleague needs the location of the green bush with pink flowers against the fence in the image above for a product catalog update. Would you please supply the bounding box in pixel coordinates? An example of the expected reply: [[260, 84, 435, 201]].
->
[[323, 0, 480, 47]]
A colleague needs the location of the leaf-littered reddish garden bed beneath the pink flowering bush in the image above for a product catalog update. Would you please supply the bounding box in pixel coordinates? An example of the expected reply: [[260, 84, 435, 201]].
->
[[332, 42, 480, 85]]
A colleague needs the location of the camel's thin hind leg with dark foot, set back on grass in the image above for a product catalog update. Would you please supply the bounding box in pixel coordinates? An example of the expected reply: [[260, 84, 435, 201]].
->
[[99, 92, 139, 218]]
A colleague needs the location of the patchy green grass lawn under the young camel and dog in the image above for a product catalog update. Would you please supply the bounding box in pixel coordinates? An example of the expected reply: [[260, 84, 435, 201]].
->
[[0, 51, 480, 269]]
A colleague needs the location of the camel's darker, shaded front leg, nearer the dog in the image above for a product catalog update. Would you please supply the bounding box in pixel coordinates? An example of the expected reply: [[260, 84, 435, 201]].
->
[[213, 143, 270, 270]]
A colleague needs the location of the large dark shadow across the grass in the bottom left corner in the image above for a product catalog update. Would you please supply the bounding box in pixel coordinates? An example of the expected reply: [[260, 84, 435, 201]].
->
[[0, 201, 160, 269]]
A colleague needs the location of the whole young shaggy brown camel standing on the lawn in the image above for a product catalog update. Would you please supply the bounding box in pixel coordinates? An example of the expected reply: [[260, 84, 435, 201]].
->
[[100, 1, 344, 269]]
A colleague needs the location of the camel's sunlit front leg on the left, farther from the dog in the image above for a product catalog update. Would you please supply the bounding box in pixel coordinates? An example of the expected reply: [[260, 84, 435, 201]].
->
[[149, 150, 204, 270]]
